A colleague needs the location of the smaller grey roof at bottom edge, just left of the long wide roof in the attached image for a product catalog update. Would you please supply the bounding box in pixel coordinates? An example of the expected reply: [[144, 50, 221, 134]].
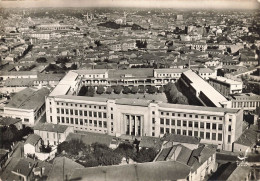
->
[[47, 157, 84, 181]]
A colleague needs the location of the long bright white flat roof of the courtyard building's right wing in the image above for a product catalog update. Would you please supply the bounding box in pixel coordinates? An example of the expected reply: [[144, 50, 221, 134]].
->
[[183, 70, 228, 107]]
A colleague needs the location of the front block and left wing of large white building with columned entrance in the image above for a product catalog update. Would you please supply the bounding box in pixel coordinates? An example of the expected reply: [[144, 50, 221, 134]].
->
[[46, 68, 243, 150]]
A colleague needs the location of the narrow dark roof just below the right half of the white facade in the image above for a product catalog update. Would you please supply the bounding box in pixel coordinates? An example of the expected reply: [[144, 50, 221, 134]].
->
[[165, 134, 200, 145]]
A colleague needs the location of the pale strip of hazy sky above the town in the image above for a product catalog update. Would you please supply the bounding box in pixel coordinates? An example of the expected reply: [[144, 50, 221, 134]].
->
[[0, 0, 260, 9]]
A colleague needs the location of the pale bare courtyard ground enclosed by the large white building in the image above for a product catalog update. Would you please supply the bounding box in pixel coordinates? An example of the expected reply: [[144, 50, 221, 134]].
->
[[94, 93, 167, 103]]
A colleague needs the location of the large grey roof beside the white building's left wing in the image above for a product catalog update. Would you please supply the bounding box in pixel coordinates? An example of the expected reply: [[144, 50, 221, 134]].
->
[[6, 88, 50, 110]]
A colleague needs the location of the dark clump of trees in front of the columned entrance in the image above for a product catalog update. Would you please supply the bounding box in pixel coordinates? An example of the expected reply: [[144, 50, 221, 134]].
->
[[57, 139, 157, 167]]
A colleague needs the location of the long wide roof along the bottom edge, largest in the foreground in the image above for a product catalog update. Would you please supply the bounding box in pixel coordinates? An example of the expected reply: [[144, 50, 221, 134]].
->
[[70, 161, 190, 181]]
